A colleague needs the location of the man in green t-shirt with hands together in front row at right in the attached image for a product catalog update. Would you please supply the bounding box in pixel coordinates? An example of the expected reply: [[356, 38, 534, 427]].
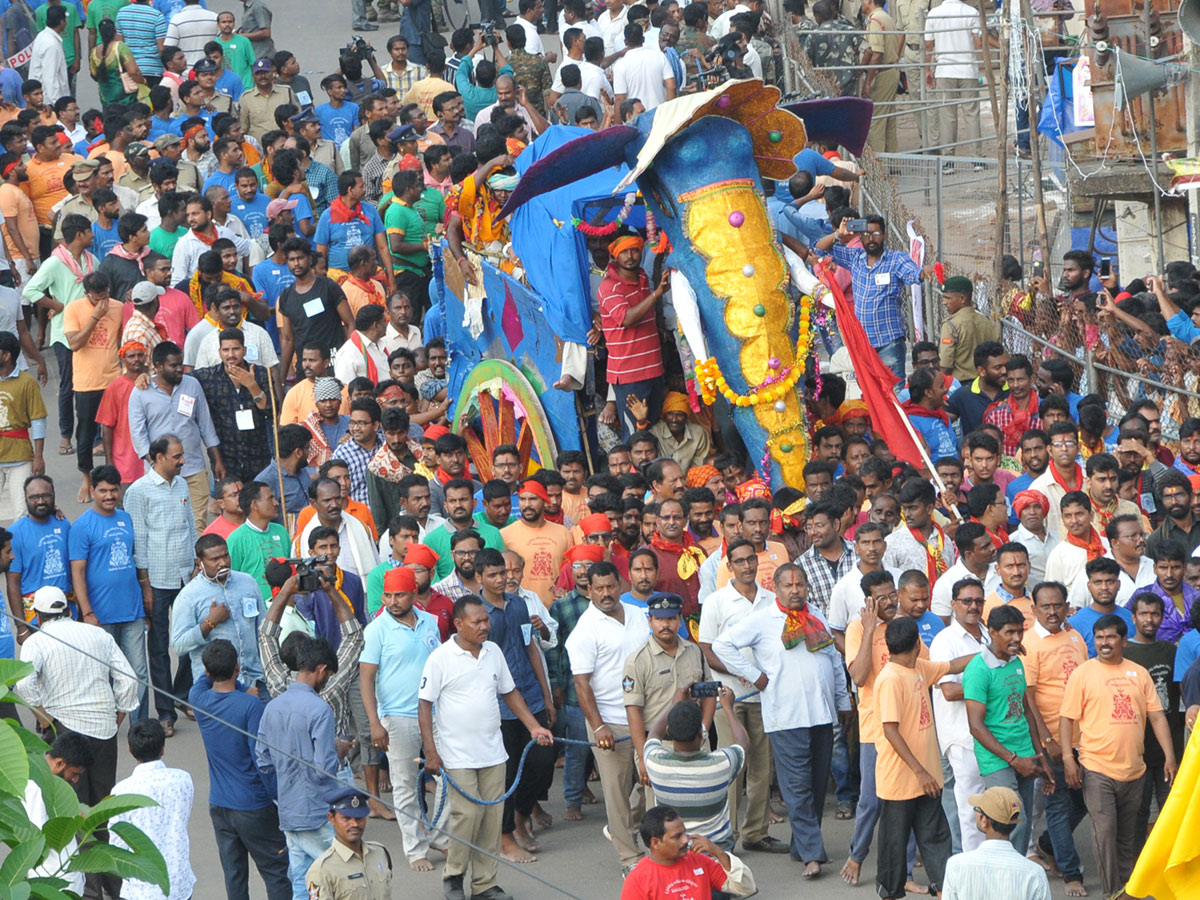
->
[[962, 606, 1054, 856]]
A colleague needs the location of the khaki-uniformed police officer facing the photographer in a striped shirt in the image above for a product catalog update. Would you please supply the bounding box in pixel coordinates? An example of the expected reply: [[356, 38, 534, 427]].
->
[[620, 590, 716, 792]]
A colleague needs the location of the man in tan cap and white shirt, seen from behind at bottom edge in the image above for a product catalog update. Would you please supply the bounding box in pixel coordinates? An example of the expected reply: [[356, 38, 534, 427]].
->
[[942, 786, 1050, 900]]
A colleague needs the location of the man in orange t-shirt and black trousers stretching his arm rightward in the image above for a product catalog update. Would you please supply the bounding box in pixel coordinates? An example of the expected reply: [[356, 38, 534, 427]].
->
[[878, 616, 971, 900]]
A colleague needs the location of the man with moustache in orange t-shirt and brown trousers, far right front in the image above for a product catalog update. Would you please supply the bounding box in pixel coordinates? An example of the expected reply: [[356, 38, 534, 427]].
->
[[1058, 614, 1176, 896]]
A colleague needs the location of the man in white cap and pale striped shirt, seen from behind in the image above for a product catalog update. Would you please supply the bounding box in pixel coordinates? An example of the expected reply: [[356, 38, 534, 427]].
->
[[16, 584, 138, 896]]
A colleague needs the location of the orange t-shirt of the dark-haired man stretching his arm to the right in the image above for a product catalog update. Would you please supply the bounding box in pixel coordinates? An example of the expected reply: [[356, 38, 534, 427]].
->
[[875, 659, 950, 800]]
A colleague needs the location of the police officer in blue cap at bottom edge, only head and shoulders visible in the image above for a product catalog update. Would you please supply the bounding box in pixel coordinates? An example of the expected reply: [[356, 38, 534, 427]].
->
[[307, 786, 391, 900]]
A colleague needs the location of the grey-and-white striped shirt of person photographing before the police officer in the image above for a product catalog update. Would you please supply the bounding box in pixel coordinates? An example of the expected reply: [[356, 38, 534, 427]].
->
[[643, 738, 739, 844]]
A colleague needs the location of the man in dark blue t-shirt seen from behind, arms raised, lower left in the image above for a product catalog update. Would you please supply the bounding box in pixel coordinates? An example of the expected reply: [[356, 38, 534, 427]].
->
[[187, 638, 292, 898]]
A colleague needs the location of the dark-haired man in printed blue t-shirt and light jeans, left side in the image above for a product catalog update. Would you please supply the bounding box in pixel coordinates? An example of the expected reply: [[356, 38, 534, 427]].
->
[[67, 466, 154, 721]]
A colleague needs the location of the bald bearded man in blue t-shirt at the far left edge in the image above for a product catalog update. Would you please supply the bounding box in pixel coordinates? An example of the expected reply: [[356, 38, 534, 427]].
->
[[8, 475, 72, 630]]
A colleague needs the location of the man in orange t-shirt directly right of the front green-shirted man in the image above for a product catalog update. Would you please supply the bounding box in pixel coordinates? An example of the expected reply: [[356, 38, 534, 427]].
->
[[1024, 583, 1087, 896]]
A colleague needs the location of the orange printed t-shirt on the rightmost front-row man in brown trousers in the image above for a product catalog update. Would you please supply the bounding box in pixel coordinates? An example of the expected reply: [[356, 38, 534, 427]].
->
[[1060, 659, 1163, 781]]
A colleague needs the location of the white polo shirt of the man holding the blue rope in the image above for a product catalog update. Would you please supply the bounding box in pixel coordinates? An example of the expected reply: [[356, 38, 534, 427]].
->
[[418, 636, 516, 769]]
